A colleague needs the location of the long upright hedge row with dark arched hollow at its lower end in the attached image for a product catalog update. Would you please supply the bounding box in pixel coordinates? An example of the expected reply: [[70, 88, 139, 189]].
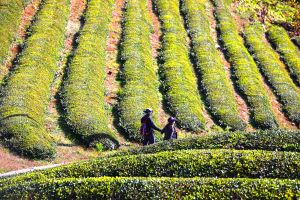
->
[[61, 0, 119, 149]]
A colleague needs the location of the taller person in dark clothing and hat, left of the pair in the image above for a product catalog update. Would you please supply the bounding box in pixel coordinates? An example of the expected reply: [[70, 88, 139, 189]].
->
[[141, 108, 161, 146]]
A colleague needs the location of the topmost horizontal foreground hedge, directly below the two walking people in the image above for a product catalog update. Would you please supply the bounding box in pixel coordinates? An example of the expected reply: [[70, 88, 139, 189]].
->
[[108, 130, 300, 156]]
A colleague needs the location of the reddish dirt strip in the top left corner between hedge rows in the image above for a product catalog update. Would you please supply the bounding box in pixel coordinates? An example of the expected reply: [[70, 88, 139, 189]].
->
[[0, 0, 41, 80]]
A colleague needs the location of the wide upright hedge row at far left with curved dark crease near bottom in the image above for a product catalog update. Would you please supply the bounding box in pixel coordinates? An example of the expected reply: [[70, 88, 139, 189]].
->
[[0, 0, 69, 158]]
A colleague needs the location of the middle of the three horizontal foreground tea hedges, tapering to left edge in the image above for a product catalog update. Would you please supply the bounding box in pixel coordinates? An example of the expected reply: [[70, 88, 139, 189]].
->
[[0, 149, 300, 187]]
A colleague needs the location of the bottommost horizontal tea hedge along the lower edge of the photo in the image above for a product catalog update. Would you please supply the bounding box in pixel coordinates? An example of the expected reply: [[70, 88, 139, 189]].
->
[[0, 177, 300, 200]]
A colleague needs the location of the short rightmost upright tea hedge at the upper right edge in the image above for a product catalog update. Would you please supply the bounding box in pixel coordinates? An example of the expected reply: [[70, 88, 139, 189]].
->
[[267, 25, 300, 85]]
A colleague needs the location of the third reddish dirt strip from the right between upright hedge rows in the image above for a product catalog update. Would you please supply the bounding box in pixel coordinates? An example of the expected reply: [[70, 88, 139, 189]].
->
[[206, 2, 253, 131]]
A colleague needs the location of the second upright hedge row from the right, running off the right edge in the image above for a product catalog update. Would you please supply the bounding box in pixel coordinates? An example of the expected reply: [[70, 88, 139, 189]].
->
[[244, 24, 300, 123]]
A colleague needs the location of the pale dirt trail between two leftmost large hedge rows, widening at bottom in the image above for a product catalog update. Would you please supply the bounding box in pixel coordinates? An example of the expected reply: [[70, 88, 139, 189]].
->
[[45, 0, 102, 160]]
